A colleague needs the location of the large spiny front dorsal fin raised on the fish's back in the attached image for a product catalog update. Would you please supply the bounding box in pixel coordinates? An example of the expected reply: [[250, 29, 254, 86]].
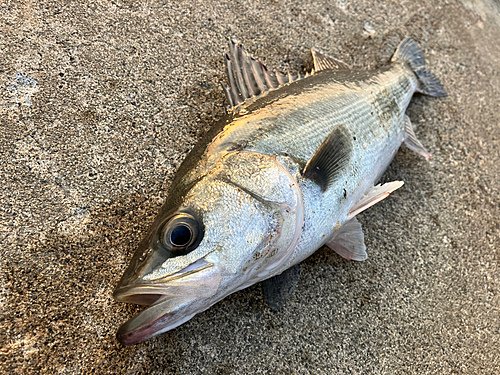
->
[[222, 39, 309, 110]]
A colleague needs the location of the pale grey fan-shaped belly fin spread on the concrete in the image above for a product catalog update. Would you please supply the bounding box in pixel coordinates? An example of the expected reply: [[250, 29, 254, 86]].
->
[[326, 218, 368, 261]]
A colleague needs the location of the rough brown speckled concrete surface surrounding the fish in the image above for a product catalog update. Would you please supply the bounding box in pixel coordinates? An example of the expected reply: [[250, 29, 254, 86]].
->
[[0, 0, 500, 374]]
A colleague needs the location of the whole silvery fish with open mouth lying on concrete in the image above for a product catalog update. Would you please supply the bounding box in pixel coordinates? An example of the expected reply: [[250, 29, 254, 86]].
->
[[113, 37, 446, 345]]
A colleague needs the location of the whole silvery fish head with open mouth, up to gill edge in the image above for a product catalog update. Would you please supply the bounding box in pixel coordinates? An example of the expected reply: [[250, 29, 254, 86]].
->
[[113, 153, 303, 344]]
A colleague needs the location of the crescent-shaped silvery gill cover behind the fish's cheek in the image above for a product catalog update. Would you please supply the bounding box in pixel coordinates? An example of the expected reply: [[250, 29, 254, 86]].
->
[[216, 151, 304, 290]]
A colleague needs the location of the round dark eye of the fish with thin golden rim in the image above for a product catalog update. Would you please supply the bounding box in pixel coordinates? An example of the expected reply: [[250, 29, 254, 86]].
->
[[160, 213, 201, 253]]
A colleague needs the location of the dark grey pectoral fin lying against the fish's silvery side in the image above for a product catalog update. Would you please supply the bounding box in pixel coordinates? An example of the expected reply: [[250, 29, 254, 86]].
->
[[302, 125, 352, 191]]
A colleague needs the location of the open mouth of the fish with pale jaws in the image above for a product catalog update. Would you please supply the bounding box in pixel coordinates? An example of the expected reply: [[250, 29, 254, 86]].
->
[[113, 260, 221, 345]]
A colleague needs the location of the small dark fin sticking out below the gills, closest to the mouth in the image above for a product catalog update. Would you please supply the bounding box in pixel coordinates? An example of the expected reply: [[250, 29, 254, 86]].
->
[[262, 264, 301, 312]]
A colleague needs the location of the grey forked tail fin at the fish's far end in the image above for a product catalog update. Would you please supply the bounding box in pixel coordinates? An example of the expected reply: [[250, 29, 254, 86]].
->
[[391, 38, 446, 96]]
